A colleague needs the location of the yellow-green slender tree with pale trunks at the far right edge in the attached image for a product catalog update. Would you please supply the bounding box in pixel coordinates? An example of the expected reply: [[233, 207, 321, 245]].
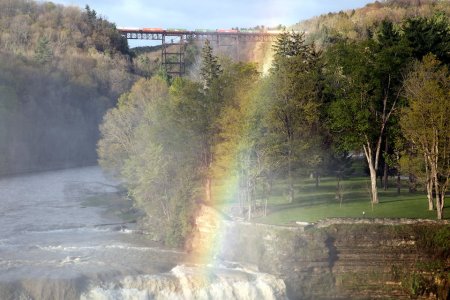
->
[[401, 55, 450, 219]]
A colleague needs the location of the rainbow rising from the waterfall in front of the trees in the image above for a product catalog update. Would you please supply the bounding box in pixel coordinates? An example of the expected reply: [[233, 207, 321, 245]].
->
[[188, 63, 271, 266]]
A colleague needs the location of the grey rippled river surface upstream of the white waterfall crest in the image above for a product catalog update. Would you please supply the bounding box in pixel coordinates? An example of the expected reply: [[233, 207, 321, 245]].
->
[[0, 167, 184, 300]]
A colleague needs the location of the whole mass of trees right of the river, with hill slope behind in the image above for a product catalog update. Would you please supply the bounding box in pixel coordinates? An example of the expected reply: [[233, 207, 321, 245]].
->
[[98, 1, 450, 245]]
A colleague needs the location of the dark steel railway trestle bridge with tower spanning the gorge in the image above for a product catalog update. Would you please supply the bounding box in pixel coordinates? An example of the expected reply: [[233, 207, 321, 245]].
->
[[118, 28, 278, 76]]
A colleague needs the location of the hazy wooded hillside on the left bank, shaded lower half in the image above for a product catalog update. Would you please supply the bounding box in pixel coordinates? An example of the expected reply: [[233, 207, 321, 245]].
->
[[0, 0, 134, 174]]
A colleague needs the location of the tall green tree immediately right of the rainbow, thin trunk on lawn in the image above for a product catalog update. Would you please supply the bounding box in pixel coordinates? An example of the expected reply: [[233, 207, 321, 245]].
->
[[265, 32, 321, 203]]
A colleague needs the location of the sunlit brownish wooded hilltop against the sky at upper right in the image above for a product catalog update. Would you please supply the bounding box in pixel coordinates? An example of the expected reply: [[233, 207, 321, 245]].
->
[[291, 0, 450, 46]]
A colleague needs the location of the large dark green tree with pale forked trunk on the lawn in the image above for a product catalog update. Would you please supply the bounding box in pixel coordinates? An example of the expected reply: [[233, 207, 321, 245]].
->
[[328, 22, 410, 203]]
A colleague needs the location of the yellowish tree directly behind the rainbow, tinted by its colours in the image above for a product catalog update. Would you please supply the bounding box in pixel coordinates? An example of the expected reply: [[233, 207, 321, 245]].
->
[[213, 63, 262, 219]]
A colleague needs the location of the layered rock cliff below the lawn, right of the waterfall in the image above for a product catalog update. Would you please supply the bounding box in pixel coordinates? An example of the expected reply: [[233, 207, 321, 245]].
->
[[189, 206, 450, 299]]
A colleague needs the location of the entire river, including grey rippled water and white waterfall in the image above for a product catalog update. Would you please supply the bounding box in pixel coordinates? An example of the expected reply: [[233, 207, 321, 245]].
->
[[0, 167, 286, 300]]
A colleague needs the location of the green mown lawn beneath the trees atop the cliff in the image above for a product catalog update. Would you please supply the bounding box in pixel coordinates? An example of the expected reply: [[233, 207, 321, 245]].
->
[[216, 177, 450, 224]]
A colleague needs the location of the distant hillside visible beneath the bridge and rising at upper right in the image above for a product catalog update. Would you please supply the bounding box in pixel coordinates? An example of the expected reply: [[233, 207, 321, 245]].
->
[[132, 0, 450, 77]]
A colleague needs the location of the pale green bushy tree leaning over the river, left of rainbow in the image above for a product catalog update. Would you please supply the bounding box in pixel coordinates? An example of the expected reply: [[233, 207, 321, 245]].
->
[[98, 77, 199, 246]]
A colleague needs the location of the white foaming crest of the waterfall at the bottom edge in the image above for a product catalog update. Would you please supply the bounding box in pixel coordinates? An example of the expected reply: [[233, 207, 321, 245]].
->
[[81, 265, 287, 300]]
